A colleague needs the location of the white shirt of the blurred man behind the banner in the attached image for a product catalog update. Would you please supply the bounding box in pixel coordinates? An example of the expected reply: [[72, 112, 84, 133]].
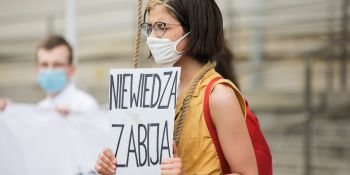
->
[[38, 84, 98, 112]]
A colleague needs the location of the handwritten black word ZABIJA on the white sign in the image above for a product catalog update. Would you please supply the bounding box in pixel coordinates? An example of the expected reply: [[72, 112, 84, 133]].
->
[[112, 121, 171, 167]]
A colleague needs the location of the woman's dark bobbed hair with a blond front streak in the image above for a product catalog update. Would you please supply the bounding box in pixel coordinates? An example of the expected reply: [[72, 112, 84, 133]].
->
[[147, 0, 225, 63]]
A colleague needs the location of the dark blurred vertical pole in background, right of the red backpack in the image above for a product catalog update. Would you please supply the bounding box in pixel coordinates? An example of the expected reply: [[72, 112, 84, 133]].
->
[[304, 58, 313, 175]]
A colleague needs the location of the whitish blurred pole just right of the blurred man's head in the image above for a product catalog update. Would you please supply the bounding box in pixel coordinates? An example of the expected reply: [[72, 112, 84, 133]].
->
[[64, 0, 79, 65]]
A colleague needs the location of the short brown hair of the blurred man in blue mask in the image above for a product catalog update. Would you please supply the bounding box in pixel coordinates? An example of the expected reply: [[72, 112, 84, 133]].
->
[[35, 35, 73, 65]]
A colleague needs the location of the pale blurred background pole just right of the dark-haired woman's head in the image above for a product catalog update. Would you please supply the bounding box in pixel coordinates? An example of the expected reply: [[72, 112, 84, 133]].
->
[[251, 0, 263, 89]]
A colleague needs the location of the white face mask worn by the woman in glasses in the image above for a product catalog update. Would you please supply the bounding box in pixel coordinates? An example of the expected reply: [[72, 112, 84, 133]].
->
[[146, 33, 189, 67]]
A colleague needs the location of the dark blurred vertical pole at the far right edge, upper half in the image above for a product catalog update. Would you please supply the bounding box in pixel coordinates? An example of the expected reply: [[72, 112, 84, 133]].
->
[[340, 0, 349, 91]]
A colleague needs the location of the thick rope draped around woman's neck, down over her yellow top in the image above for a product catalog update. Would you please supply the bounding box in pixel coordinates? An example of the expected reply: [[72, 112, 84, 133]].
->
[[174, 62, 216, 145]]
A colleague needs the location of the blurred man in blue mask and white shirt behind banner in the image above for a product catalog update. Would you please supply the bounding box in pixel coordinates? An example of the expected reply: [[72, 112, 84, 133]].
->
[[0, 36, 98, 115]]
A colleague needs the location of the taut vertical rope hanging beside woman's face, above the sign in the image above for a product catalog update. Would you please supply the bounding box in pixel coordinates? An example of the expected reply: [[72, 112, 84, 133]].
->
[[132, 0, 142, 68]]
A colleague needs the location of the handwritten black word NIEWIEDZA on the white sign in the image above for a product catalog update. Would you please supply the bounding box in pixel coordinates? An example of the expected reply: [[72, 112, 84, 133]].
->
[[109, 71, 178, 110]]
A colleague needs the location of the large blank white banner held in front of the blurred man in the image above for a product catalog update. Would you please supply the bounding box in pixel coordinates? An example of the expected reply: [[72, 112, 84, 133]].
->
[[0, 104, 108, 175]]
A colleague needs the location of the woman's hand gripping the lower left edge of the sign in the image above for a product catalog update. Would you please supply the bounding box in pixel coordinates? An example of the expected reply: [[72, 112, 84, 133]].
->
[[95, 148, 117, 175]]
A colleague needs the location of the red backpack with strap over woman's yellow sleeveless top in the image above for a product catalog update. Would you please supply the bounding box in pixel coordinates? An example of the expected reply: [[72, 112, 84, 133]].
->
[[204, 77, 272, 175]]
